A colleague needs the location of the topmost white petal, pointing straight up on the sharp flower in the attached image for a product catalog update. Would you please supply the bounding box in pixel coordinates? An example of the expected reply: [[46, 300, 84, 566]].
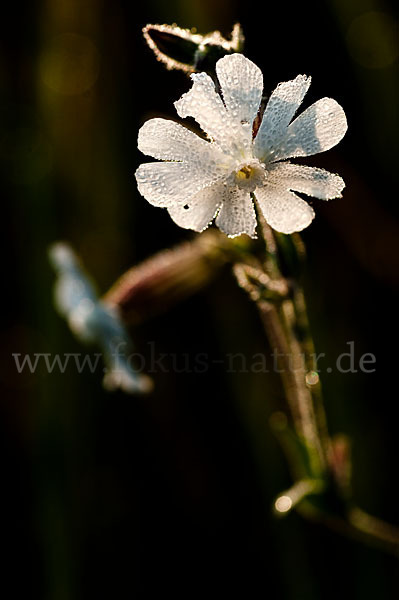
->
[[216, 54, 263, 126]]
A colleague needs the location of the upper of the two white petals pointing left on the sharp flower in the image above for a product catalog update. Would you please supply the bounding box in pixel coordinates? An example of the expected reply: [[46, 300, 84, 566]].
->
[[138, 119, 227, 161]]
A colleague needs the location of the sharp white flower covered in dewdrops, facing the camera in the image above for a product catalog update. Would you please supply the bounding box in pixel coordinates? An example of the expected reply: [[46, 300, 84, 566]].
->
[[136, 54, 347, 237]]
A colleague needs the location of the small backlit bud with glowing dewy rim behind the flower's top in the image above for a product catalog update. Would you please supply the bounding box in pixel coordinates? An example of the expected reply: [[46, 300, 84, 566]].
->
[[143, 23, 244, 73]]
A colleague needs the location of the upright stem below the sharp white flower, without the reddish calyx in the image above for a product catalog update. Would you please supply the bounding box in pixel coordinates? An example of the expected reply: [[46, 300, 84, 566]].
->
[[241, 226, 399, 556]]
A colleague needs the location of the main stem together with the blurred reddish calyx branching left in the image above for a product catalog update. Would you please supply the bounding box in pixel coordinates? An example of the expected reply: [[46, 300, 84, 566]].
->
[[99, 222, 399, 554]]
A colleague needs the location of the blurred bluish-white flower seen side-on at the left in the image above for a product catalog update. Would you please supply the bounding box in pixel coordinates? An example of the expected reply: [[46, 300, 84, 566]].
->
[[49, 243, 152, 394]]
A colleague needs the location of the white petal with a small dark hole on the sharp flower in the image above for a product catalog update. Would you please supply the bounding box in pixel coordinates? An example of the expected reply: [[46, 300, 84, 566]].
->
[[168, 183, 225, 231]]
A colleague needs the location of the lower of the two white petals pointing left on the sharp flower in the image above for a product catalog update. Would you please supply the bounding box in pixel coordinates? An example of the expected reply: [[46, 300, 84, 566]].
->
[[136, 162, 221, 207]]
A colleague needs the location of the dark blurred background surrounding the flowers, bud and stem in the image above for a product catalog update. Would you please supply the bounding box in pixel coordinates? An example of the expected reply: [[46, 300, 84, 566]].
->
[[0, 0, 399, 600]]
